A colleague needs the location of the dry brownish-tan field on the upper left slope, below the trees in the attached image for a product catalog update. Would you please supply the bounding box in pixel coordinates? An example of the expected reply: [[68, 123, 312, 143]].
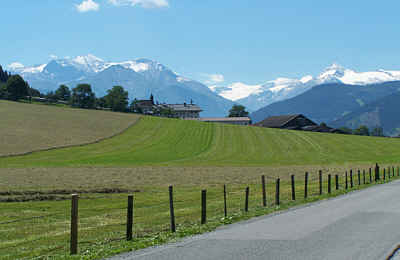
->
[[0, 100, 138, 156]]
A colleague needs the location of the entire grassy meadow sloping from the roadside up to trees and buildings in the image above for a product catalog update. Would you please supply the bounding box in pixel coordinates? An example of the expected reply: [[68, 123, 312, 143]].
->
[[0, 102, 400, 259]]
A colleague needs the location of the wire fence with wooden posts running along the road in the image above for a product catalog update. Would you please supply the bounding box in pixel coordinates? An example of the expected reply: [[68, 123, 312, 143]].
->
[[0, 164, 400, 259]]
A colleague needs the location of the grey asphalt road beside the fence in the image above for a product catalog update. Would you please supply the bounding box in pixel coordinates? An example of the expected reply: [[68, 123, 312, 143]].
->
[[111, 181, 400, 260]]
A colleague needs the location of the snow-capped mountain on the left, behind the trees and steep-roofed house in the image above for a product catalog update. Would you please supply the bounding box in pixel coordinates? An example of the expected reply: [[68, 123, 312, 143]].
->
[[7, 54, 233, 116]]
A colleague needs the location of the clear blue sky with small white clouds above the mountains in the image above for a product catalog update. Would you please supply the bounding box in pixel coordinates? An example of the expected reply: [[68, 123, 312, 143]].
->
[[0, 0, 400, 84]]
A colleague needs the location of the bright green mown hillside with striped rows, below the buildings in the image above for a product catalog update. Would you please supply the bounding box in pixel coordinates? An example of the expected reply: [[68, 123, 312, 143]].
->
[[0, 117, 400, 168]]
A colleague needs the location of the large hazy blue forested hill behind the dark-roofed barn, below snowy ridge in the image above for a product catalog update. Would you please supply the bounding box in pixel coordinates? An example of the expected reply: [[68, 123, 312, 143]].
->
[[251, 81, 400, 123]]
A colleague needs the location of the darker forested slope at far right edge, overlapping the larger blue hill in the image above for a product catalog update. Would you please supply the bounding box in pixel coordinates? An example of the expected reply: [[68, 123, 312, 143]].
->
[[329, 92, 400, 135]]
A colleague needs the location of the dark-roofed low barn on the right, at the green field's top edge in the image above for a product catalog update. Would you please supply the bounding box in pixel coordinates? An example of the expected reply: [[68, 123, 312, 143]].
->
[[255, 114, 343, 133]]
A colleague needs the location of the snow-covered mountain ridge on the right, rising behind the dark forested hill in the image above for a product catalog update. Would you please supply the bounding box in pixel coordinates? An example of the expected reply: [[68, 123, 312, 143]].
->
[[210, 64, 400, 111]]
